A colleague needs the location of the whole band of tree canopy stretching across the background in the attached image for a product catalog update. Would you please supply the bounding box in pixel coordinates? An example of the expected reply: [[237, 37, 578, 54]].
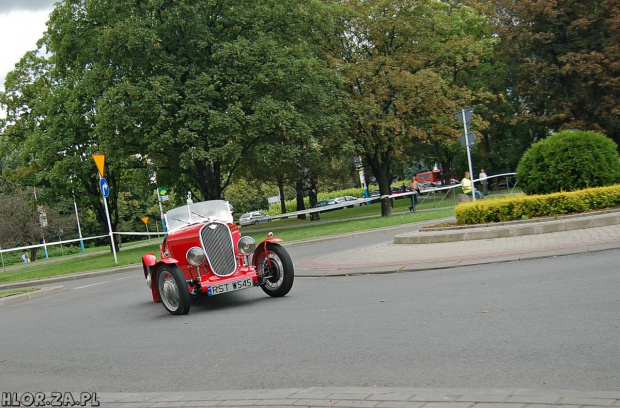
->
[[0, 0, 620, 234]]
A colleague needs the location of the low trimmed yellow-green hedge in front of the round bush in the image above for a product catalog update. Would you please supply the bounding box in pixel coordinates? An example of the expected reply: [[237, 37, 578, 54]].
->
[[454, 184, 620, 225]]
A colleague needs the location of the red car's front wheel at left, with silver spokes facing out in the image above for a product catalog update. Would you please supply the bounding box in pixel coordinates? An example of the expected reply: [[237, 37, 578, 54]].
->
[[155, 265, 191, 315]]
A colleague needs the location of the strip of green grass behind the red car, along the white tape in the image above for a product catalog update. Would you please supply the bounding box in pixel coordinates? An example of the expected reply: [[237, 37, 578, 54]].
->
[[0, 200, 454, 283]]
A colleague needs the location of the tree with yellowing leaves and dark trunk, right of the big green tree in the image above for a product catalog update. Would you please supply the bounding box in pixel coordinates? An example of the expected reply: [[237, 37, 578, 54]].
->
[[335, 0, 493, 216]]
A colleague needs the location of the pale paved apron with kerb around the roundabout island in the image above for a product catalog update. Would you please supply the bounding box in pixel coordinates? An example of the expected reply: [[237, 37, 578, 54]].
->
[[295, 211, 620, 276]]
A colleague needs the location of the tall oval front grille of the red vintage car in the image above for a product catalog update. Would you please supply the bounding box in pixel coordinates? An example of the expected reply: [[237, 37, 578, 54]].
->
[[200, 222, 237, 276]]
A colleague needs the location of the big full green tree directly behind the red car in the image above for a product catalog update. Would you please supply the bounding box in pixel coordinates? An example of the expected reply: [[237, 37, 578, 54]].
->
[[83, 0, 344, 199]]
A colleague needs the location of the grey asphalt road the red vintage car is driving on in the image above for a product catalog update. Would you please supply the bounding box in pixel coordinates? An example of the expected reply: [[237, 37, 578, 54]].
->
[[0, 243, 620, 392]]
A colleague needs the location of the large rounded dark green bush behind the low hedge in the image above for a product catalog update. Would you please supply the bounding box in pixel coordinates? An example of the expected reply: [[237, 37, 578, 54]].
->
[[517, 131, 620, 194]]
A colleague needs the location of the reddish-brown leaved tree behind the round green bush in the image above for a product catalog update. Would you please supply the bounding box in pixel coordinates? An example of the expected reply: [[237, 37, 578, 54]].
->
[[497, 0, 620, 143]]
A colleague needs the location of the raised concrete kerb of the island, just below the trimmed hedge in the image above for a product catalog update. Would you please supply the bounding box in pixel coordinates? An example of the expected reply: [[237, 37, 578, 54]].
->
[[394, 210, 620, 244]]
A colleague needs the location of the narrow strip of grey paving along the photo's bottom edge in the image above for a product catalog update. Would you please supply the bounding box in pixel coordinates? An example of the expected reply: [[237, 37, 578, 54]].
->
[[89, 387, 620, 408]]
